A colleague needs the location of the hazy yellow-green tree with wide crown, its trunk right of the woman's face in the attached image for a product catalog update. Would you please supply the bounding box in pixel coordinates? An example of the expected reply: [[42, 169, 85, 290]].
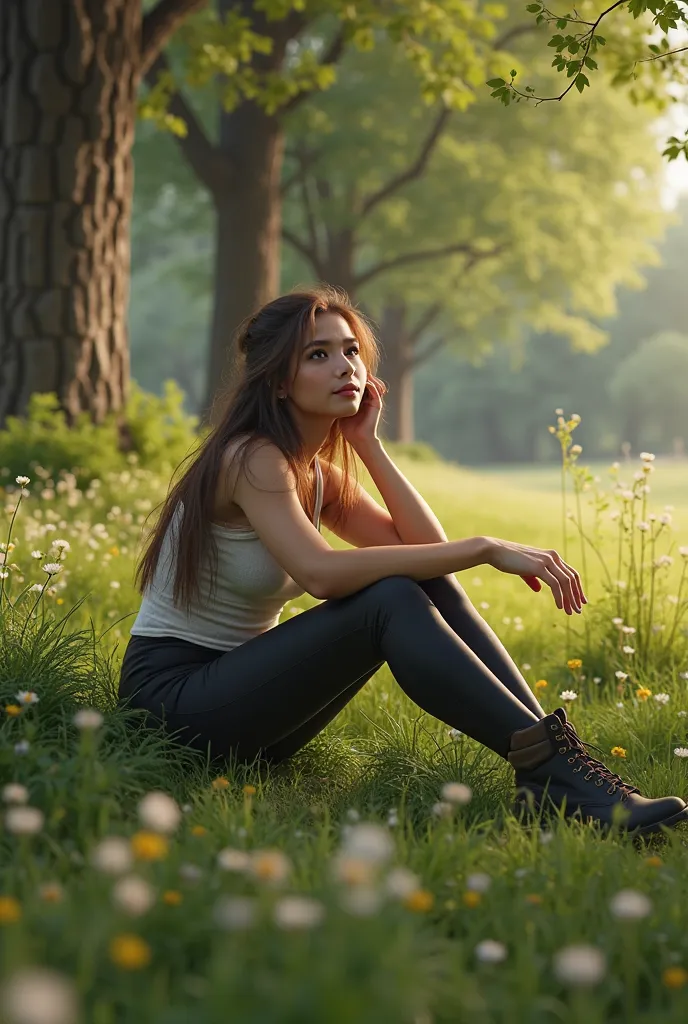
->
[[278, 40, 662, 441]]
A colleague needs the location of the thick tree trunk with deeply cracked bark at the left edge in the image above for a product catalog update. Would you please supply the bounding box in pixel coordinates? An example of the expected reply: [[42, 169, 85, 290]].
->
[[0, 0, 141, 424]]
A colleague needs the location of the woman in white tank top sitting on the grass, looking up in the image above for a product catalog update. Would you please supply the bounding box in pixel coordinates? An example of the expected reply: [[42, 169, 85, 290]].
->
[[120, 286, 688, 833]]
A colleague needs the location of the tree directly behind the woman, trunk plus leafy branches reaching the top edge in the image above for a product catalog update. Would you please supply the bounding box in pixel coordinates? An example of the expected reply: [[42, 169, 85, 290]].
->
[[141, 0, 528, 410]]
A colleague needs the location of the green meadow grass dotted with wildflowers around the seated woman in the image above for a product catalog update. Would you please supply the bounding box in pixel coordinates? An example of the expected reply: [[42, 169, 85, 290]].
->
[[0, 434, 688, 1024]]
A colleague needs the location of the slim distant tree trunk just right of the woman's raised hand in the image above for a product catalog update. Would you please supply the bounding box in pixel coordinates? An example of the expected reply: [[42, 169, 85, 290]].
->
[[380, 302, 415, 443]]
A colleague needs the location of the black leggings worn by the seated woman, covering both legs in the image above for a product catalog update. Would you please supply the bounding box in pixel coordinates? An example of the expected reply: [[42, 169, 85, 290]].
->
[[120, 575, 546, 764]]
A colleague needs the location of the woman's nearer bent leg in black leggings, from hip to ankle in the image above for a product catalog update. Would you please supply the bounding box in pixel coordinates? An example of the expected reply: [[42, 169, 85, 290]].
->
[[119, 577, 539, 760]]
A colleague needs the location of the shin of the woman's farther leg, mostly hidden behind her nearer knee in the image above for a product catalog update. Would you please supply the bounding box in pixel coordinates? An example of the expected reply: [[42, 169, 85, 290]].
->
[[419, 575, 547, 718]]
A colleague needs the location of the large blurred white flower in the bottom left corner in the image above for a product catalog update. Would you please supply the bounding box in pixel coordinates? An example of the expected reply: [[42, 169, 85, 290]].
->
[[0, 966, 80, 1024]]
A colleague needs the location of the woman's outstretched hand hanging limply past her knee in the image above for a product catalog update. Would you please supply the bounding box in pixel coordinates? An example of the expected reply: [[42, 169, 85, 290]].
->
[[487, 537, 588, 615]]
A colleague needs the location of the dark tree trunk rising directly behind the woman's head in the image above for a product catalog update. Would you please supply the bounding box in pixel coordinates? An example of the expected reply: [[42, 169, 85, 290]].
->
[[205, 101, 285, 419]]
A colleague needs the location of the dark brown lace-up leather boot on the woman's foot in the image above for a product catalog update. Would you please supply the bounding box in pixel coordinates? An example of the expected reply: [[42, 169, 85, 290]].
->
[[508, 708, 688, 836]]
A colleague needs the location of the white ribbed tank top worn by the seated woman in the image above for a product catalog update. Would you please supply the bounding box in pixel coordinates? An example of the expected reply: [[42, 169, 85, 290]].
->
[[131, 456, 323, 650]]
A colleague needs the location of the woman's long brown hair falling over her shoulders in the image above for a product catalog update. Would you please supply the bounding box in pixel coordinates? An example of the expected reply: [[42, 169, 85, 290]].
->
[[134, 285, 387, 613]]
